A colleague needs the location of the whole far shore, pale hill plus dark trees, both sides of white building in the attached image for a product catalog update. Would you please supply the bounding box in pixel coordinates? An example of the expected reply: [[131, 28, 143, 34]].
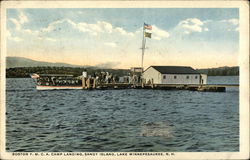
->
[[6, 57, 239, 78]]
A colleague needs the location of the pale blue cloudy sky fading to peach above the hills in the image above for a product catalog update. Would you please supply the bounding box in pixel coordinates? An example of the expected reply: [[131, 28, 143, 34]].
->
[[6, 8, 239, 69]]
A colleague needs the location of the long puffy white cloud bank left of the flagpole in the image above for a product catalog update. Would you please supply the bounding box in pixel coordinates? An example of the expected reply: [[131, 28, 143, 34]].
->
[[9, 15, 135, 43]]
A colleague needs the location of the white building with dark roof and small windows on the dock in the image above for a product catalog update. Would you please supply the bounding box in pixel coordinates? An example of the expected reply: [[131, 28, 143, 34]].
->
[[143, 66, 207, 84]]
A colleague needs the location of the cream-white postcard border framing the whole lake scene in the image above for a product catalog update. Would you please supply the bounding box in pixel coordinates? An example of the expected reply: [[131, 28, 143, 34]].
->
[[0, 1, 249, 160]]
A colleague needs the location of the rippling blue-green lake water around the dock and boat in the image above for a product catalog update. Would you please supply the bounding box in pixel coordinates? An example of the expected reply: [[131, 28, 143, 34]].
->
[[6, 76, 239, 152]]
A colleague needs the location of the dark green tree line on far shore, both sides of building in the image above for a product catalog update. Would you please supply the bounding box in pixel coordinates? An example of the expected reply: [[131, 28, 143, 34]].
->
[[6, 67, 239, 78]]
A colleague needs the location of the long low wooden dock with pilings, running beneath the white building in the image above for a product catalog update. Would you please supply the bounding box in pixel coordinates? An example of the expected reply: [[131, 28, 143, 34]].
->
[[82, 79, 239, 92]]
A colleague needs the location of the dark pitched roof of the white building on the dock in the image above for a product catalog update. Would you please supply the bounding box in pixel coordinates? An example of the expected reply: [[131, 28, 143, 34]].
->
[[145, 66, 200, 74]]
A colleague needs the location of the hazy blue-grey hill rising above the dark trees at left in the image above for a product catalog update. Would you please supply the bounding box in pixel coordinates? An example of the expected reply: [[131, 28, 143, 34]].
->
[[6, 57, 86, 68]]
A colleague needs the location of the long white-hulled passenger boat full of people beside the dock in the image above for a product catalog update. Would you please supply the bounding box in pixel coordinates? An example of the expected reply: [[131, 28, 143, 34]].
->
[[31, 74, 82, 90]]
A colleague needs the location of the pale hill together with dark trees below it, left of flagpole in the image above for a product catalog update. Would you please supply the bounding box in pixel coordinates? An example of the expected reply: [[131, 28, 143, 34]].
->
[[6, 57, 130, 78]]
